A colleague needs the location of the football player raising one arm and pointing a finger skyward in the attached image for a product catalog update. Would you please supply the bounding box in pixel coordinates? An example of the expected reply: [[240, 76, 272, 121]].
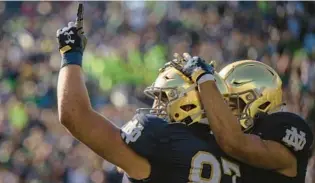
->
[[57, 4, 241, 183]]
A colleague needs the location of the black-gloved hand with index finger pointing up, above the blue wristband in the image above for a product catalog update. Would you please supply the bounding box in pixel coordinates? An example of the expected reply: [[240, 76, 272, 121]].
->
[[57, 3, 87, 55]]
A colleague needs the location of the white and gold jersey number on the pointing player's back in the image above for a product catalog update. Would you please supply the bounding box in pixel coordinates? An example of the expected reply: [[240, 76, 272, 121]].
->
[[189, 151, 241, 183]]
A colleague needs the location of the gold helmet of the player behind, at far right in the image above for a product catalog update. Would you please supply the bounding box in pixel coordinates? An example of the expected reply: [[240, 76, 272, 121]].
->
[[219, 60, 283, 131]]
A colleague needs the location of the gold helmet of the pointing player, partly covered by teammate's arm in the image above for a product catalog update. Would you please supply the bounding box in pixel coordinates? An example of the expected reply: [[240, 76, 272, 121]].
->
[[144, 61, 228, 125]]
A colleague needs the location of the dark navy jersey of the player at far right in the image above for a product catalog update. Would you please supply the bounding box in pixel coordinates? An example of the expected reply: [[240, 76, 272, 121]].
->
[[241, 112, 313, 183]]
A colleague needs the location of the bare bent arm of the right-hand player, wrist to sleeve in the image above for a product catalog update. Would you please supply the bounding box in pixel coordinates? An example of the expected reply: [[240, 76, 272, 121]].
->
[[199, 81, 297, 177]]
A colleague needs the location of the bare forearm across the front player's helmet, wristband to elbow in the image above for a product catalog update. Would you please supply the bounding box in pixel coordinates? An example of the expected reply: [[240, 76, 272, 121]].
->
[[199, 81, 244, 151]]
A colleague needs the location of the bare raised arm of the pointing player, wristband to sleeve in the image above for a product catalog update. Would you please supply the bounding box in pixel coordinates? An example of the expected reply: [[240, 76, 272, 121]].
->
[[57, 65, 150, 179]]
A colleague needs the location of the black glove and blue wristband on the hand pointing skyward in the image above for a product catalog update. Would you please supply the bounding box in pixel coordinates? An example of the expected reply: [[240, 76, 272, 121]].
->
[[57, 4, 87, 67]]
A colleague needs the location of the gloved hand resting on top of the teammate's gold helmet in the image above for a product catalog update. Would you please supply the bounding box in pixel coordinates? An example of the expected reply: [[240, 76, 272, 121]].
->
[[177, 53, 214, 84]]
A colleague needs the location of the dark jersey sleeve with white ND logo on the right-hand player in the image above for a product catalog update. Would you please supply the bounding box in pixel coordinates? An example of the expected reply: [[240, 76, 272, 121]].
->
[[264, 113, 313, 157]]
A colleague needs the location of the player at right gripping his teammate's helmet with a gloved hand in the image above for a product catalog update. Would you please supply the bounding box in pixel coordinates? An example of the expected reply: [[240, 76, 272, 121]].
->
[[179, 54, 313, 183]]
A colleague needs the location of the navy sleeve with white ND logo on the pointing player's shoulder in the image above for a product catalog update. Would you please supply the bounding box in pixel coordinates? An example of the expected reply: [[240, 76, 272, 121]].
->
[[120, 114, 166, 159]]
